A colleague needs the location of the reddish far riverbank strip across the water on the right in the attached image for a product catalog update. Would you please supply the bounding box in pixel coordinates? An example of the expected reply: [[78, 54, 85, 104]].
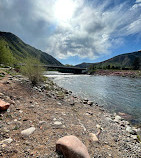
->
[[91, 69, 141, 78]]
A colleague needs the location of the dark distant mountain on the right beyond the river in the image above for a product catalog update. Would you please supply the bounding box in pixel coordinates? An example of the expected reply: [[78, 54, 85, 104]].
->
[[77, 50, 141, 69]]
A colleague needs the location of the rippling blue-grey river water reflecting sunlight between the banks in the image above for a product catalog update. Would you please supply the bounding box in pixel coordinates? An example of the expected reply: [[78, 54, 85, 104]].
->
[[47, 72, 141, 124]]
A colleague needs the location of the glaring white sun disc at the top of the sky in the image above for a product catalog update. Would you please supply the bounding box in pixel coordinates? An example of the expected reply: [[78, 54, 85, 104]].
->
[[54, 0, 75, 22]]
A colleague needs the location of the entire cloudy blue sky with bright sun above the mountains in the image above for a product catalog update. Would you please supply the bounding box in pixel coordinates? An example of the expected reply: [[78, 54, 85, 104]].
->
[[0, 0, 141, 65]]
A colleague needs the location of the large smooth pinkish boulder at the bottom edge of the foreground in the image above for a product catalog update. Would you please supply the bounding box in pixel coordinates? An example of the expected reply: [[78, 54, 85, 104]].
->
[[56, 135, 90, 158]]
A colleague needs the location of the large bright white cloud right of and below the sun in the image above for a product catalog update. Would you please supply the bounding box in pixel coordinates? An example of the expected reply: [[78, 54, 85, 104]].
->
[[44, 0, 140, 59]]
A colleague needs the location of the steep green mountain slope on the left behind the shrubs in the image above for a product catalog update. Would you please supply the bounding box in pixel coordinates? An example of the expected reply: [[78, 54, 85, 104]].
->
[[0, 32, 62, 66]]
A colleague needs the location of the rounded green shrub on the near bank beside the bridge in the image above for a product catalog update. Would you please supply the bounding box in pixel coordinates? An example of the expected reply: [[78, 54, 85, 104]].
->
[[20, 57, 44, 85]]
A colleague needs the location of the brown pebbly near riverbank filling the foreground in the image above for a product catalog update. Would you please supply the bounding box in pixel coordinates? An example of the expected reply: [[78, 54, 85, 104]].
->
[[0, 69, 141, 158]]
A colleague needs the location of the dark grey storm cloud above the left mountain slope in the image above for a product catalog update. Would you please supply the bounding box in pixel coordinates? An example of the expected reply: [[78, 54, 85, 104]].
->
[[0, 0, 50, 50]]
